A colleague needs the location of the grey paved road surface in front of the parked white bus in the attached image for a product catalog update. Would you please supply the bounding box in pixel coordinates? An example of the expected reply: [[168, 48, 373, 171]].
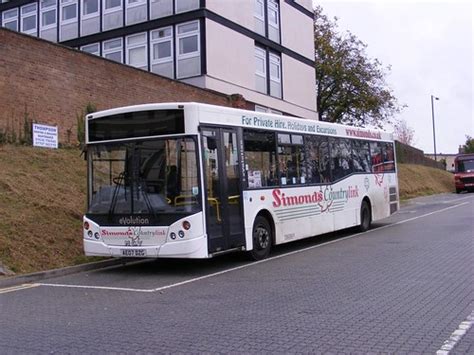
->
[[0, 194, 474, 354]]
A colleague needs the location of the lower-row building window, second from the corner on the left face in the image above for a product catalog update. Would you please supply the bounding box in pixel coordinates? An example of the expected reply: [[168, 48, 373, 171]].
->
[[150, 27, 174, 78]]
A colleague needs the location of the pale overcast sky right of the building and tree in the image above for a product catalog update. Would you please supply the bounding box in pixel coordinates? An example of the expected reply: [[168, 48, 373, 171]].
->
[[313, 0, 474, 154]]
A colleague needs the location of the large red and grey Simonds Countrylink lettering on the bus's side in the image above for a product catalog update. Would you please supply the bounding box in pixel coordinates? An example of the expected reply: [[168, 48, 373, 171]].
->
[[272, 186, 359, 208]]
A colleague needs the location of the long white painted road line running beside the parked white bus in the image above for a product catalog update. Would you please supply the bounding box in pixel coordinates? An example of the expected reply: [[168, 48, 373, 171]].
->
[[29, 202, 469, 293]]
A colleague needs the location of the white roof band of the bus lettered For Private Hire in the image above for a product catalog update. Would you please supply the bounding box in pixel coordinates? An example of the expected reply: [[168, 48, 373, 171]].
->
[[87, 102, 393, 141]]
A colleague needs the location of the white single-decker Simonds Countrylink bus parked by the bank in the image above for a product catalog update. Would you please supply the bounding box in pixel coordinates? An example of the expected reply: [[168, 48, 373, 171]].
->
[[83, 103, 399, 260]]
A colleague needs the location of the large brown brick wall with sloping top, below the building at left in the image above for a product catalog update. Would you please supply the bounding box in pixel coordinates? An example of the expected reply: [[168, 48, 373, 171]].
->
[[0, 28, 235, 144]]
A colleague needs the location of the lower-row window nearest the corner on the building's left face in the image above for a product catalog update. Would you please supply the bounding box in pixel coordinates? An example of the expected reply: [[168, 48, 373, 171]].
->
[[176, 21, 201, 79]]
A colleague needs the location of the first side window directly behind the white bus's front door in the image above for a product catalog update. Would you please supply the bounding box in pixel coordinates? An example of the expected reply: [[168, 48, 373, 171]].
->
[[244, 129, 278, 189]]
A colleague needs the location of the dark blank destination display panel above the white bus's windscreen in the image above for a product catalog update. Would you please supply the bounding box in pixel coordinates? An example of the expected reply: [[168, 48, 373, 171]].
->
[[87, 110, 184, 142]]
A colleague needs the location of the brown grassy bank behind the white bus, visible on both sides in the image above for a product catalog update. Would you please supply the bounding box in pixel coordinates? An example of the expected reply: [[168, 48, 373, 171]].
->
[[0, 145, 453, 273]]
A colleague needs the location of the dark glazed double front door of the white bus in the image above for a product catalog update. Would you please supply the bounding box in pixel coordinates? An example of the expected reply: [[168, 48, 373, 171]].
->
[[201, 127, 245, 253]]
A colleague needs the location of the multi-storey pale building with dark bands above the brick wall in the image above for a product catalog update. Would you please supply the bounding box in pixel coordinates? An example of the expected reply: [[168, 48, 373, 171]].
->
[[0, 0, 318, 119]]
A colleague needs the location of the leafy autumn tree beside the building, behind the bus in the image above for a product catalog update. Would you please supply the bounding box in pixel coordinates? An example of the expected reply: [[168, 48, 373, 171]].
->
[[314, 6, 402, 127]]
